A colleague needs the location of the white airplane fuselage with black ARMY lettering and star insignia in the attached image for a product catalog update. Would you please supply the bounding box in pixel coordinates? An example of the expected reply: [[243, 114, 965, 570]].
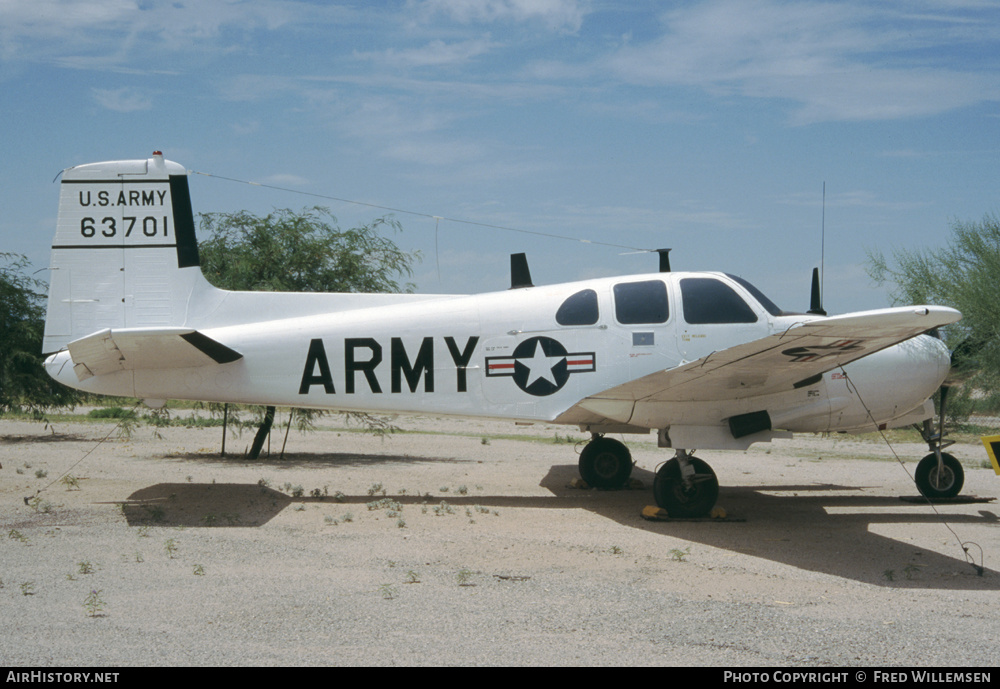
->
[[48, 268, 948, 448]]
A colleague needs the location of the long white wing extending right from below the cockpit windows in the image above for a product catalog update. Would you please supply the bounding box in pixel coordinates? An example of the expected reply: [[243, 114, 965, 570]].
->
[[567, 306, 962, 423]]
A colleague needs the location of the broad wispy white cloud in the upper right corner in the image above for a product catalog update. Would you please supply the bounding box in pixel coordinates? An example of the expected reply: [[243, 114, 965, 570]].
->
[[610, 0, 1000, 124]]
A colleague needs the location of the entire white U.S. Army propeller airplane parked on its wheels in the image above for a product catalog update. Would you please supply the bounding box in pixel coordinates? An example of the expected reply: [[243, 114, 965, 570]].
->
[[43, 152, 963, 517]]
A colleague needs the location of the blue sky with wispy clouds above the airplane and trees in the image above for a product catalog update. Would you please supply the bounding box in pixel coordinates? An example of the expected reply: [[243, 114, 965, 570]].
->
[[0, 0, 1000, 312]]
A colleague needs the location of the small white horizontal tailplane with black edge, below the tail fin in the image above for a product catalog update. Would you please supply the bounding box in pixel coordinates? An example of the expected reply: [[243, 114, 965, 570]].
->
[[67, 328, 243, 381]]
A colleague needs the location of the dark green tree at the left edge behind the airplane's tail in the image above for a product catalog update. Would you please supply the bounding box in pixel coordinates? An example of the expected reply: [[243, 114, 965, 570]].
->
[[0, 253, 79, 413]]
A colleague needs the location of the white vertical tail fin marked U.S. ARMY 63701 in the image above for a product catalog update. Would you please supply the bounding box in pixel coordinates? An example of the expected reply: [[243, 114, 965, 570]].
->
[[43, 152, 203, 353]]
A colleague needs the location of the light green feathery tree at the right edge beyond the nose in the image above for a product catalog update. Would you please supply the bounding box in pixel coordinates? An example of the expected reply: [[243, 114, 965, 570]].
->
[[868, 214, 1000, 396]]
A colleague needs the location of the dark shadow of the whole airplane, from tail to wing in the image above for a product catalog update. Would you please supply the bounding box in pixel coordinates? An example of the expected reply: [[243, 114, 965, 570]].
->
[[123, 455, 1000, 590]]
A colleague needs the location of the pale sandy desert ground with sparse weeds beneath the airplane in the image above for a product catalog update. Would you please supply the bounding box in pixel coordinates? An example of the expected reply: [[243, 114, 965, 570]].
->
[[0, 417, 1000, 668]]
